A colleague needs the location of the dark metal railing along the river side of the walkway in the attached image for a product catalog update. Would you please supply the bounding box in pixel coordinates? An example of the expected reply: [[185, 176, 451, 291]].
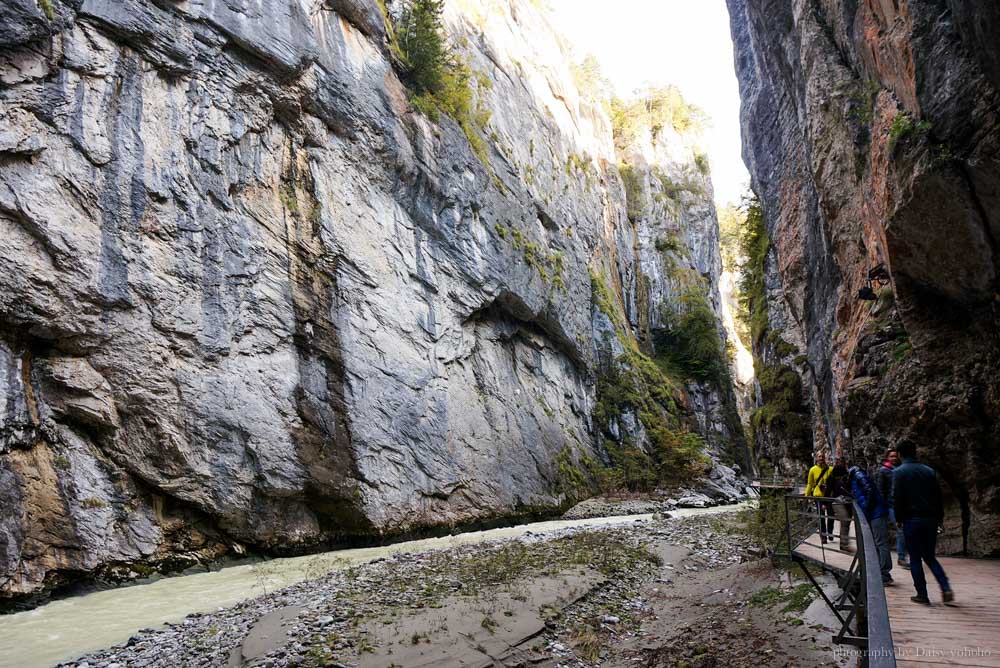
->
[[785, 494, 896, 668]]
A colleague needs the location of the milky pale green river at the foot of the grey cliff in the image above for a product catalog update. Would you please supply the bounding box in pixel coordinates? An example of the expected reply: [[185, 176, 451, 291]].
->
[[0, 506, 739, 668]]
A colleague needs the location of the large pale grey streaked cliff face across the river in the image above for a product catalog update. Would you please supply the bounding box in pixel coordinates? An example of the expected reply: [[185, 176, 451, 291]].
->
[[0, 0, 741, 596]]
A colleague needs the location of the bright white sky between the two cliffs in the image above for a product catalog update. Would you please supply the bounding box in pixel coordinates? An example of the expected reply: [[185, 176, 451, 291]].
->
[[548, 0, 750, 205]]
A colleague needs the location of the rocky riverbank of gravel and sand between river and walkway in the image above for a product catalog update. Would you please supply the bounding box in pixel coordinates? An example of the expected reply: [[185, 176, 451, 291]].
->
[[63, 513, 844, 668]]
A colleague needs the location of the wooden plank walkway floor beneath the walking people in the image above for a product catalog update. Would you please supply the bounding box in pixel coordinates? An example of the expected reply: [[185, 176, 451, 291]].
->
[[795, 525, 1000, 668]]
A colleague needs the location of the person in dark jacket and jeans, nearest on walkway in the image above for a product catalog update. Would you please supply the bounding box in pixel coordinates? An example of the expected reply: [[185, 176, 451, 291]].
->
[[892, 441, 955, 605]]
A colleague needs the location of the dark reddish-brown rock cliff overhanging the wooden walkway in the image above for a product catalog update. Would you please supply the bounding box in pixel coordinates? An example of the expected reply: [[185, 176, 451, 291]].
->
[[729, 0, 1000, 555]]
